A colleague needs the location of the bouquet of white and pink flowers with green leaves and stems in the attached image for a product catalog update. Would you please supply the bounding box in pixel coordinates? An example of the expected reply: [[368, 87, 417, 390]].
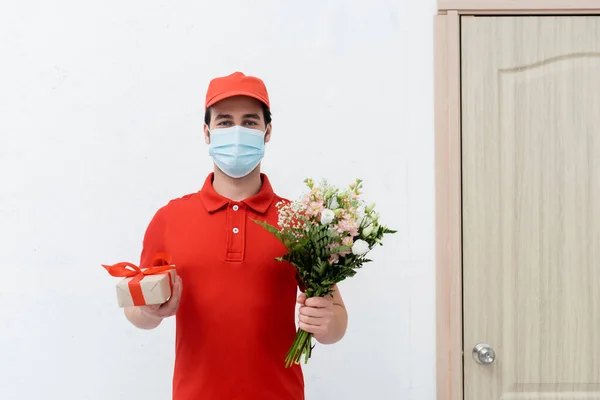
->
[[255, 178, 396, 367]]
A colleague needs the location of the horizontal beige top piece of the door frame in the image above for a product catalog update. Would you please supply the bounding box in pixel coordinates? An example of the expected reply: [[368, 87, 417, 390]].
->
[[438, 0, 600, 12]]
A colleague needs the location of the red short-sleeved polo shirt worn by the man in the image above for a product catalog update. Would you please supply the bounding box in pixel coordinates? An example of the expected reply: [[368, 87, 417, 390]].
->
[[140, 173, 304, 400]]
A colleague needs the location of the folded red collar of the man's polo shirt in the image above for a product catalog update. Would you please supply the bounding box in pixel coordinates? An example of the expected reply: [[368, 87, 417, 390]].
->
[[200, 172, 275, 214]]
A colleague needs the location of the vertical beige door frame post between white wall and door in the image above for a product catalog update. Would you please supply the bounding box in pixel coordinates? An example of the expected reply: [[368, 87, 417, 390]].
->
[[434, 11, 463, 400]]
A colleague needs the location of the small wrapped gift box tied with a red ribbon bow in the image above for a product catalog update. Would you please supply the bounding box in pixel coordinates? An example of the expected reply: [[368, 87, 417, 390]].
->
[[102, 253, 177, 307]]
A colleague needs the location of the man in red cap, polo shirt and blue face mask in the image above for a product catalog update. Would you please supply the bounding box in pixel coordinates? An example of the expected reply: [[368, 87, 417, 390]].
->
[[125, 72, 347, 400]]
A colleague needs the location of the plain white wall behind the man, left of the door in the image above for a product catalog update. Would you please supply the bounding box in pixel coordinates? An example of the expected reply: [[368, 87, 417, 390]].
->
[[0, 0, 435, 400]]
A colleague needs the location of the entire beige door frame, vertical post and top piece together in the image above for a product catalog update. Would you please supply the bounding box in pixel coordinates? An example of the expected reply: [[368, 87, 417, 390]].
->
[[434, 0, 600, 400]]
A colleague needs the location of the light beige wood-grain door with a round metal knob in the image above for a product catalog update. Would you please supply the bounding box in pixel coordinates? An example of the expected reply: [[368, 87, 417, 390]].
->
[[461, 16, 600, 400]]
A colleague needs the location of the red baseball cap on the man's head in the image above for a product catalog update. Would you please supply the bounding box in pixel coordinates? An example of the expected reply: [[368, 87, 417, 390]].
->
[[204, 72, 271, 108]]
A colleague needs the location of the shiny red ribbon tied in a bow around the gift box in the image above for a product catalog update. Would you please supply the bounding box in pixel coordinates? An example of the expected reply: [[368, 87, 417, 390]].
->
[[102, 253, 175, 306]]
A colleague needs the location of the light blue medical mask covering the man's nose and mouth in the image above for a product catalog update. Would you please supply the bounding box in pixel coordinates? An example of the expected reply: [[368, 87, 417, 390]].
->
[[208, 125, 266, 178]]
